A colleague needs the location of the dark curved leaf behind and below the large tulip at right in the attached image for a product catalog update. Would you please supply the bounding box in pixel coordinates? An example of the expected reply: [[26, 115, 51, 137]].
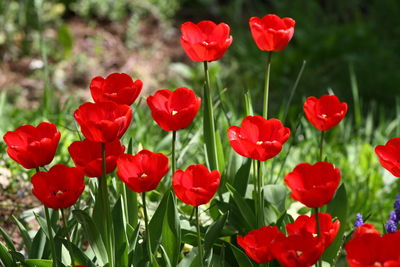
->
[[322, 184, 348, 263]]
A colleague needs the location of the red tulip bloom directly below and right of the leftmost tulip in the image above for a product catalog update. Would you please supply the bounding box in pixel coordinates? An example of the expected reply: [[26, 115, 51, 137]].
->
[[31, 164, 85, 209]]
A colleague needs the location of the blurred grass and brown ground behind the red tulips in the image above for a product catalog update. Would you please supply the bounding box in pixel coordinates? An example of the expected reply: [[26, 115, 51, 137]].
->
[[0, 0, 400, 253]]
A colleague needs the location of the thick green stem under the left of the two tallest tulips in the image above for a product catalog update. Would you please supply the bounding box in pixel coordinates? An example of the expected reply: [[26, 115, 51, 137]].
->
[[204, 61, 219, 170]]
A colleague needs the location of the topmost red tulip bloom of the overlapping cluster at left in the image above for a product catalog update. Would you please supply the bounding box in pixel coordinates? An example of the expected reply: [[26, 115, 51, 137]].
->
[[90, 73, 143, 106]]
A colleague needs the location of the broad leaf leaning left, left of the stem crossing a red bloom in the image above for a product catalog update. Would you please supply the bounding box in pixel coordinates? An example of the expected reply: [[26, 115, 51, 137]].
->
[[72, 210, 108, 265]]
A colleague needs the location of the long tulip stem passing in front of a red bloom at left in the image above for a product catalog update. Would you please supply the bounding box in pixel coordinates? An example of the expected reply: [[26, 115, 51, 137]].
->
[[99, 143, 114, 267]]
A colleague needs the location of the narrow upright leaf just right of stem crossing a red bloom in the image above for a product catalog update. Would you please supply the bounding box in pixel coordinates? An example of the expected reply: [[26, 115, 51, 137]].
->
[[112, 197, 128, 266]]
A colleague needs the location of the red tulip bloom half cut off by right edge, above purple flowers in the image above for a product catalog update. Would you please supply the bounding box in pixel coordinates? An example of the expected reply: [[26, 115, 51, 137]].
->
[[375, 138, 400, 177]]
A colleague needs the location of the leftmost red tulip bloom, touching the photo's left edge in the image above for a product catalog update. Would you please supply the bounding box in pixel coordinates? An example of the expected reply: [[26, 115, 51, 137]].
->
[[3, 122, 61, 169]]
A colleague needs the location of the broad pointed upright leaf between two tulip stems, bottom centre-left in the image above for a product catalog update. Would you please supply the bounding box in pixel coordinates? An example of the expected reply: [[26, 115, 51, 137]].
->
[[161, 192, 181, 266]]
